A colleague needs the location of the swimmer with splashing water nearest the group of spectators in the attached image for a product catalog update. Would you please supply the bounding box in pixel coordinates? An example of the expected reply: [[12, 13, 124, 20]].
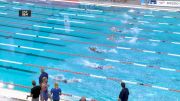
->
[[50, 75, 81, 83]]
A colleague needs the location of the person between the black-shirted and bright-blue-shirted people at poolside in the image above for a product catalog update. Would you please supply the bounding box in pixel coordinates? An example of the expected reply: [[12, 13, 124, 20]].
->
[[41, 77, 48, 101]]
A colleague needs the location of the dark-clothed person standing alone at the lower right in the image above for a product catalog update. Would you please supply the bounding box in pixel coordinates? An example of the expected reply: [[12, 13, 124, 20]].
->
[[119, 82, 129, 101]]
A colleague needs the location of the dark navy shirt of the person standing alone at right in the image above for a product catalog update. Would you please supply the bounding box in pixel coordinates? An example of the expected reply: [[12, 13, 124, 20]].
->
[[119, 88, 129, 101]]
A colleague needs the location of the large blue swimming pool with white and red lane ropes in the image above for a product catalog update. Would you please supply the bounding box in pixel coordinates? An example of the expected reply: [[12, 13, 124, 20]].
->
[[0, 1, 180, 101]]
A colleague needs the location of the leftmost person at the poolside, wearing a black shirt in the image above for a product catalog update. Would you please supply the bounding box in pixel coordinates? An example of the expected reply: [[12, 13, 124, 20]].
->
[[27, 80, 41, 101]]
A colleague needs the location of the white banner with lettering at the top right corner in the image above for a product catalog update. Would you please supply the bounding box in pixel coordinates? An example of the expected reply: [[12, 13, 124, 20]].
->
[[157, 0, 180, 7]]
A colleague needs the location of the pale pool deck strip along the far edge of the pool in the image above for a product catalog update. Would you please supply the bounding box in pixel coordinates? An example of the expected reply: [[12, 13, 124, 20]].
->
[[49, 0, 180, 12]]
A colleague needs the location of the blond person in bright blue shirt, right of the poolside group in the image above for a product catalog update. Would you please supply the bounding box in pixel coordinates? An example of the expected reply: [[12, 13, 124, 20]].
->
[[51, 83, 61, 101]]
